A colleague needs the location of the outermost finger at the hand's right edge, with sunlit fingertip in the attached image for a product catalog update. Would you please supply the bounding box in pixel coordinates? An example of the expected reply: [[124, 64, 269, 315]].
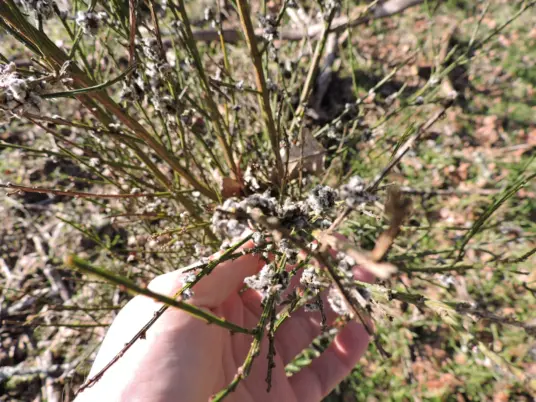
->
[[289, 322, 369, 401]]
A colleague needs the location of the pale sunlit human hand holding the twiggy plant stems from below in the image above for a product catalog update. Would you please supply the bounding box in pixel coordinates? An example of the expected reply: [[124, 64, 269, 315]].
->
[[76, 242, 372, 402]]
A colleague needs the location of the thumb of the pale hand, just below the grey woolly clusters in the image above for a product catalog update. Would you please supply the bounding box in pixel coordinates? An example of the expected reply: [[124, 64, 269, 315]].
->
[[149, 241, 264, 308]]
